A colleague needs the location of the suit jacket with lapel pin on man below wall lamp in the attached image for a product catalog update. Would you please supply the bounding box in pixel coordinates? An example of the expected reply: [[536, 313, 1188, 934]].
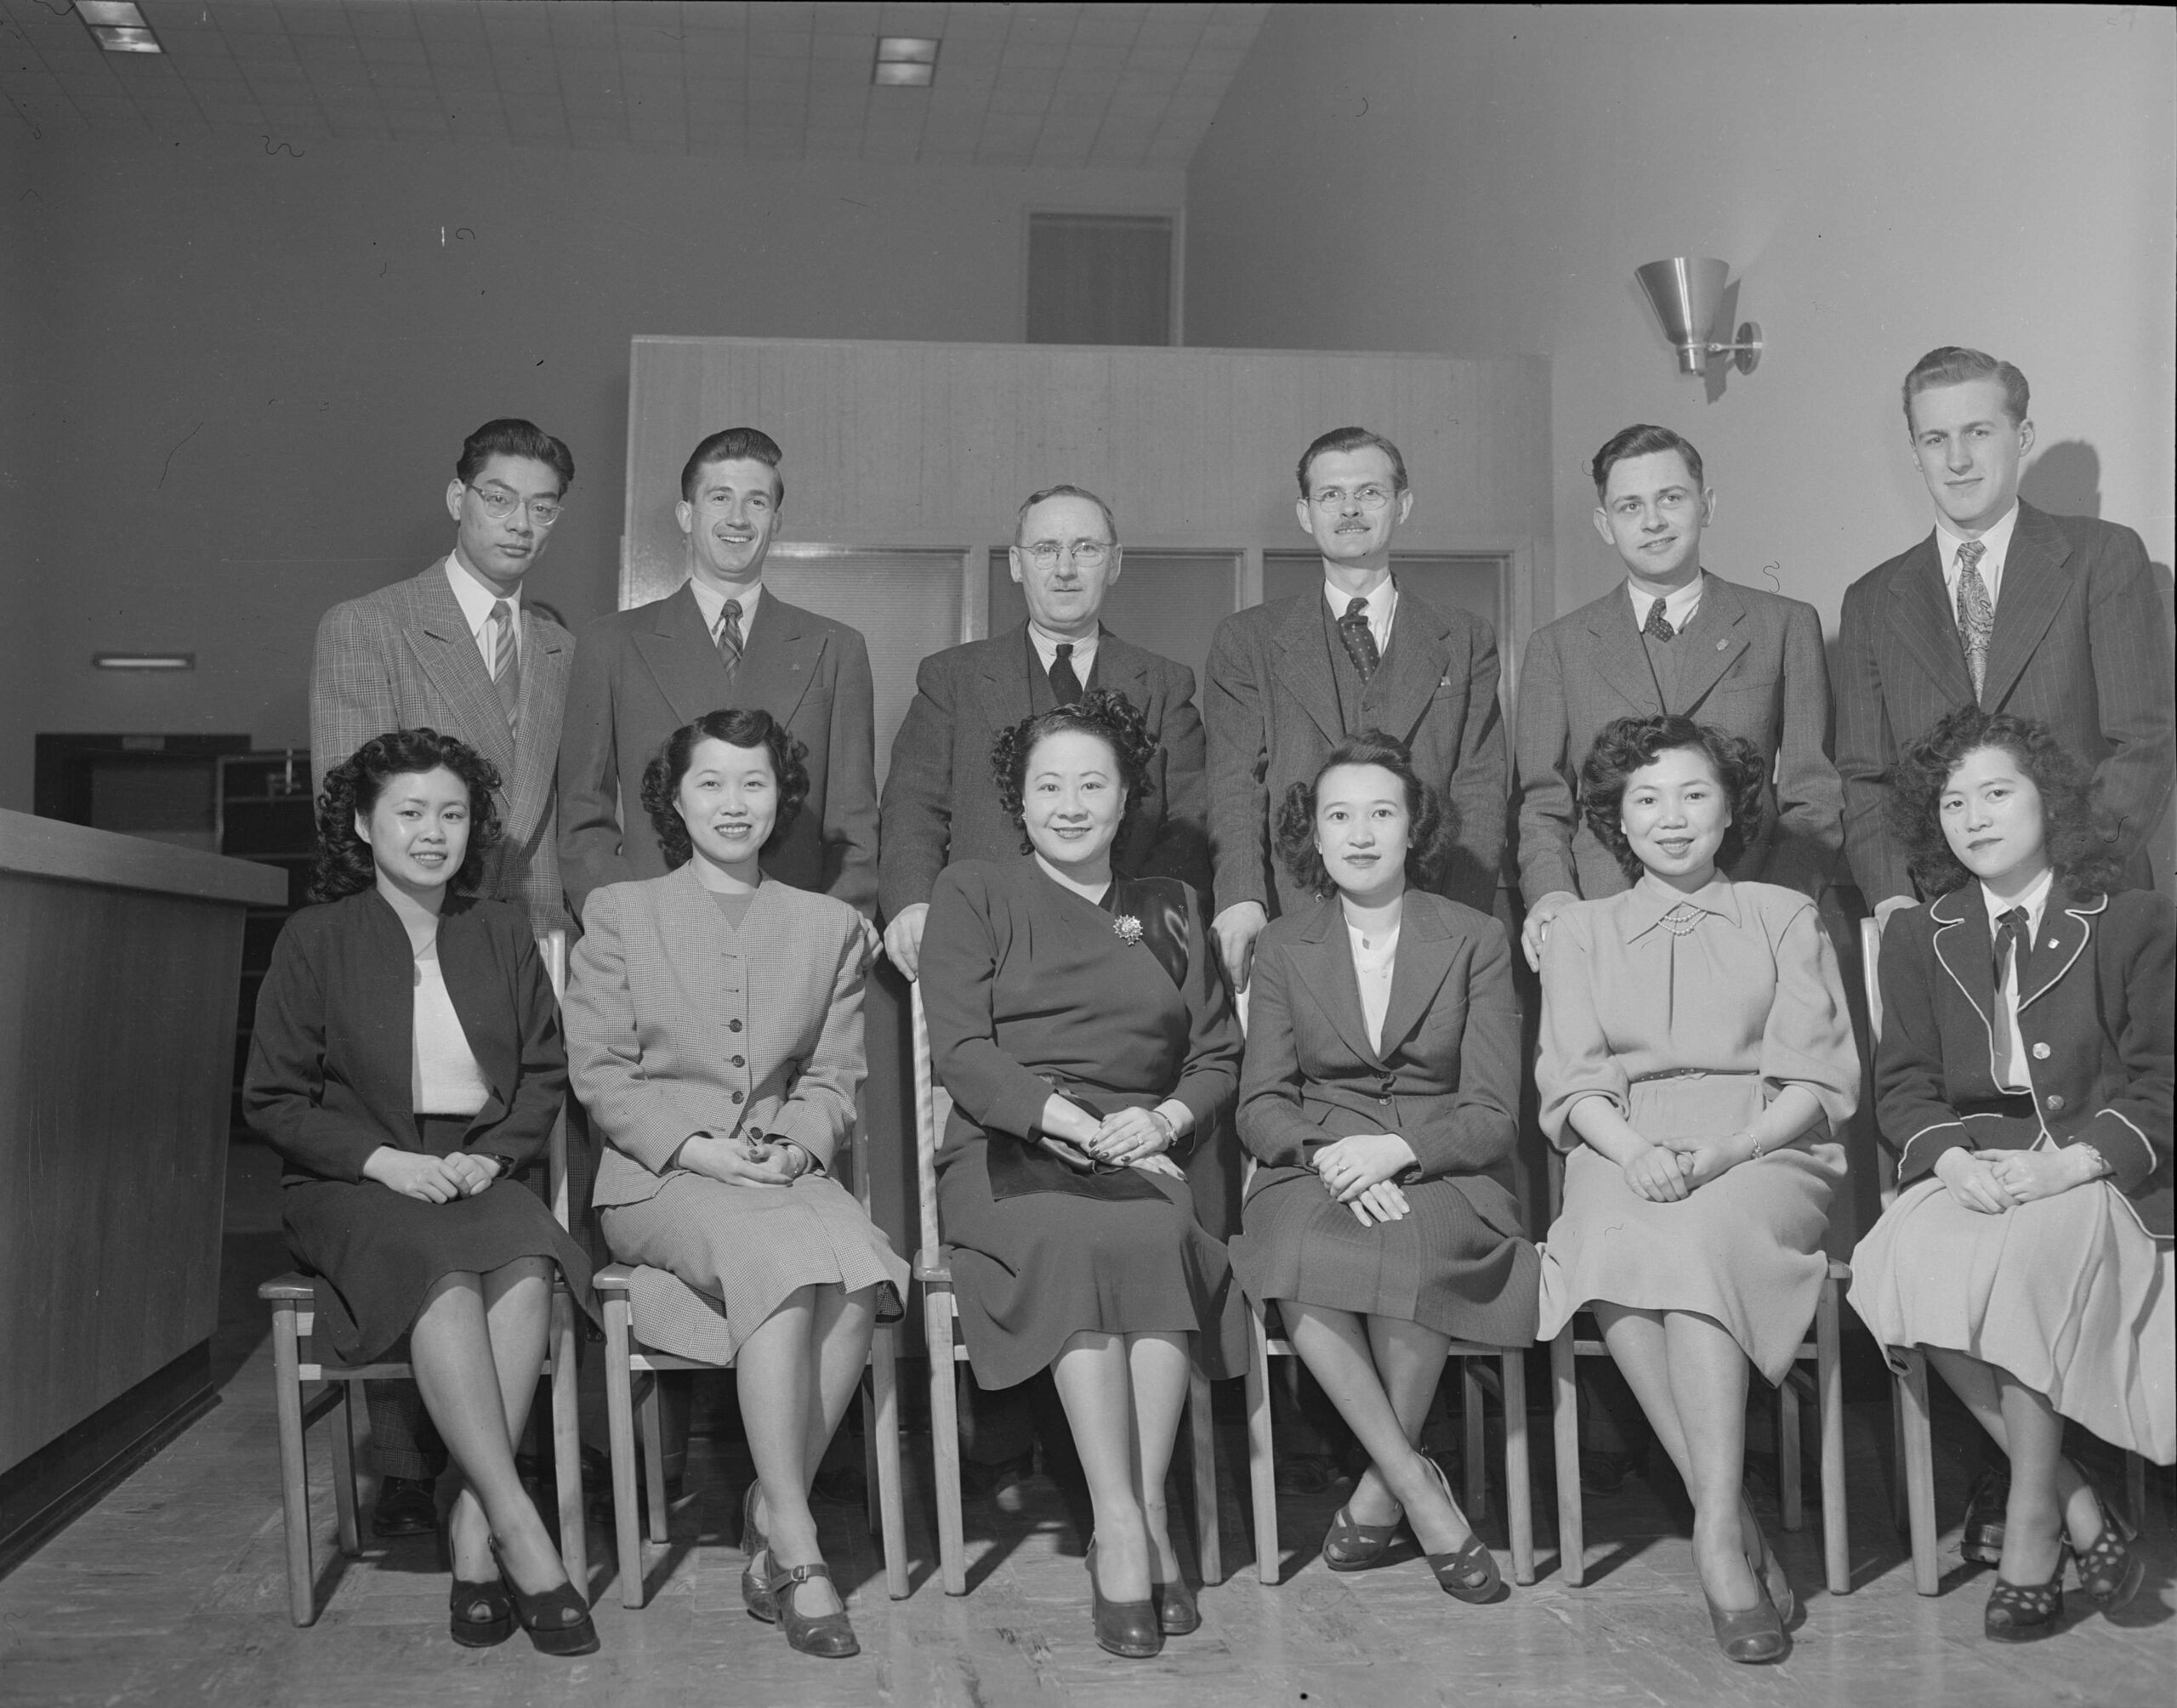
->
[[1515, 570, 1844, 905]]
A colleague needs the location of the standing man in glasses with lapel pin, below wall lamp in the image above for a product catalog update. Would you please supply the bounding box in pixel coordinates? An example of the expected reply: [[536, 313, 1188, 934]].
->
[[1515, 424, 1844, 968]]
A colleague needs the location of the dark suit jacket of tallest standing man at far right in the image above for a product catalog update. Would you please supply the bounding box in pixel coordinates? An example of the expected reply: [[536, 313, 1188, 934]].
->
[[1838, 505, 2177, 907]]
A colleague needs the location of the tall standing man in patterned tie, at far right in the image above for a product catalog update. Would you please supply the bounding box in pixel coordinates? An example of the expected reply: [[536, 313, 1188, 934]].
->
[[1838, 346, 2177, 921]]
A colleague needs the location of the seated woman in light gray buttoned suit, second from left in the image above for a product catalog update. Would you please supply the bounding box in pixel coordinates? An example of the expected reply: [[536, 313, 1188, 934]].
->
[[566, 709, 908, 1658]]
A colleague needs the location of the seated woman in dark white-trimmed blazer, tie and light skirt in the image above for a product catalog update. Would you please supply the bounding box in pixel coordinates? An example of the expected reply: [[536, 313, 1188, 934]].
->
[[1853, 705, 2177, 1643]]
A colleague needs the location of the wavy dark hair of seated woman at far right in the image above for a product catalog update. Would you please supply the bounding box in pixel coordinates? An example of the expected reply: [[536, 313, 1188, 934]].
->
[[1890, 705, 2123, 901]]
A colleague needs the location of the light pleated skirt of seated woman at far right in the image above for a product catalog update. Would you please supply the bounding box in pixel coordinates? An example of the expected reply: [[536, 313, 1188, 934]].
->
[[1850, 1179, 2177, 1464]]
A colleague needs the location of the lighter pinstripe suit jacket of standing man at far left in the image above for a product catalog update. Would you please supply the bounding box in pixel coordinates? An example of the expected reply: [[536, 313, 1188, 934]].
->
[[310, 559, 575, 933]]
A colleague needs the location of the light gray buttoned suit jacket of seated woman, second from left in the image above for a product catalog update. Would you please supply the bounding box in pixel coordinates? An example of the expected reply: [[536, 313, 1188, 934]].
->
[[566, 866, 867, 1207]]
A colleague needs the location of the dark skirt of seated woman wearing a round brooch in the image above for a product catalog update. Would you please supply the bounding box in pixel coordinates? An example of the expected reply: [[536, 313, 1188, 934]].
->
[[938, 1138, 1248, 1388]]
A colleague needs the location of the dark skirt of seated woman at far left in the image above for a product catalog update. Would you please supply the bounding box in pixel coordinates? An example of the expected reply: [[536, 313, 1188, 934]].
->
[[283, 1116, 596, 1365]]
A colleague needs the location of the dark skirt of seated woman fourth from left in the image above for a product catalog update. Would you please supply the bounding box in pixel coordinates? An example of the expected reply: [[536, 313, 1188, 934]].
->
[[1232, 1168, 1541, 1347]]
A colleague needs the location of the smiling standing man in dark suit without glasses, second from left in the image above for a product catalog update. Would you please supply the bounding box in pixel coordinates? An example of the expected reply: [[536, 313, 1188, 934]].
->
[[560, 427, 878, 914]]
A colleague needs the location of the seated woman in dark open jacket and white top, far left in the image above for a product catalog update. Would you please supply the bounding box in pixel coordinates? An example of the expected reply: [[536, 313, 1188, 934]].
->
[[242, 729, 596, 1654]]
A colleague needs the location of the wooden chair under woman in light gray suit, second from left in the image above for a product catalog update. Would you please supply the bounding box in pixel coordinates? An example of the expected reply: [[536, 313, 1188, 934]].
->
[[596, 1105, 908, 1608]]
